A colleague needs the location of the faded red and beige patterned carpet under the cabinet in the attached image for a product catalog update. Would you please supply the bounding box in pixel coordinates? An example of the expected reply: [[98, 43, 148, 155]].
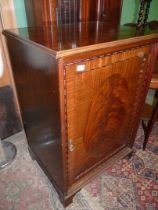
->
[[0, 124, 158, 210]]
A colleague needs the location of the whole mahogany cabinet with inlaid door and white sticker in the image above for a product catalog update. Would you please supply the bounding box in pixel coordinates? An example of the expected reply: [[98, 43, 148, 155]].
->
[[4, 22, 158, 205]]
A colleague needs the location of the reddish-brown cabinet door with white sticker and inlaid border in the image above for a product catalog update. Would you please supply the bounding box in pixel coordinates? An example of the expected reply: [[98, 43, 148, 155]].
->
[[65, 47, 150, 184]]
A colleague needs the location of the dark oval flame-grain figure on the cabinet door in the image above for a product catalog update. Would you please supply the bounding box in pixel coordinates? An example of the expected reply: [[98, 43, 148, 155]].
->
[[83, 73, 129, 155]]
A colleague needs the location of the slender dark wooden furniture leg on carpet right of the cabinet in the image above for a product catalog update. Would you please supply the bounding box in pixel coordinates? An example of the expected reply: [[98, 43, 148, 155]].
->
[[142, 102, 158, 150]]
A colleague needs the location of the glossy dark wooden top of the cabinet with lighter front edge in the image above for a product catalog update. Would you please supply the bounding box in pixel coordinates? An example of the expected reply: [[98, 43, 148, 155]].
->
[[4, 22, 158, 57]]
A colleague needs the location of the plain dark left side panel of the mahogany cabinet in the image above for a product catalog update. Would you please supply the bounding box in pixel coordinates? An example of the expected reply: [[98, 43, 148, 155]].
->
[[7, 36, 64, 191]]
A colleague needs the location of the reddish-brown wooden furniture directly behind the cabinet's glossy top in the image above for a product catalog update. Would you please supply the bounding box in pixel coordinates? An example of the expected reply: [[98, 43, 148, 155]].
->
[[25, 0, 122, 26]]
